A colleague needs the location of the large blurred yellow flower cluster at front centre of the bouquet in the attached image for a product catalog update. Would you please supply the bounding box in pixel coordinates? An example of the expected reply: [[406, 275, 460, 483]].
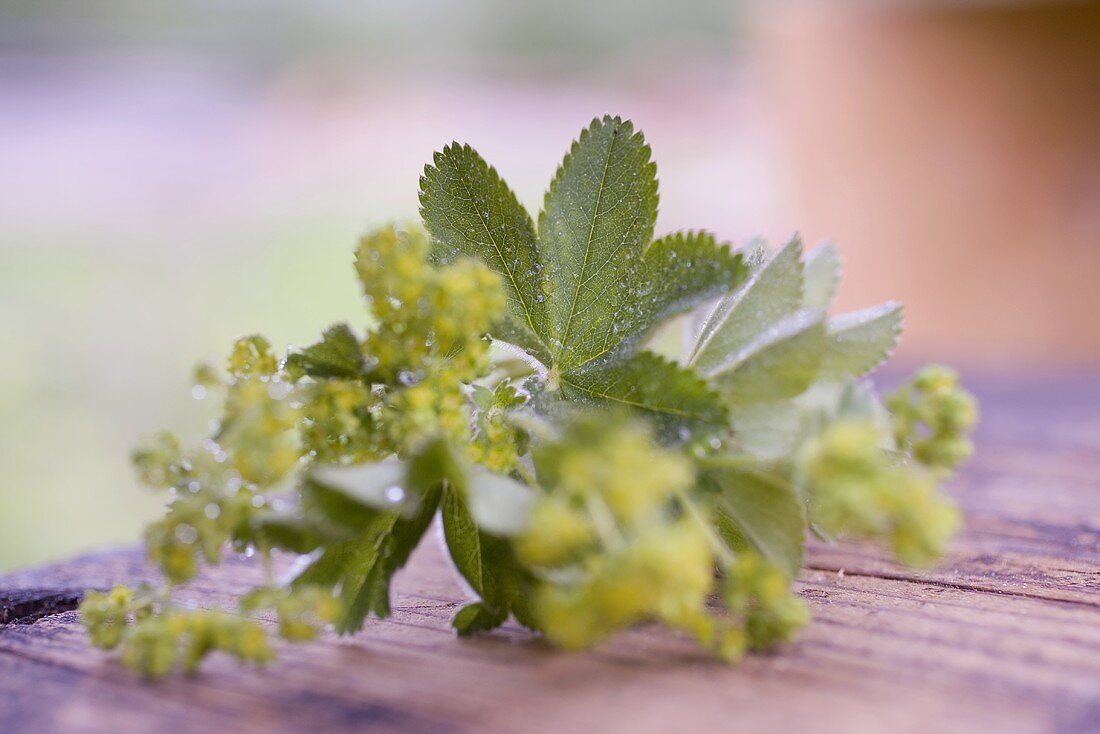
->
[[516, 418, 730, 649]]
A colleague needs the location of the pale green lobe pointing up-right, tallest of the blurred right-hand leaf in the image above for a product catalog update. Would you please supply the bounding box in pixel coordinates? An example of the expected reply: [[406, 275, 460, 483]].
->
[[688, 237, 802, 376]]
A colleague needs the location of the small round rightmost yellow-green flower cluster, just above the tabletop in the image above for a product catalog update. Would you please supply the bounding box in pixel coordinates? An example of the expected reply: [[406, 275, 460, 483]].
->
[[886, 365, 978, 473]]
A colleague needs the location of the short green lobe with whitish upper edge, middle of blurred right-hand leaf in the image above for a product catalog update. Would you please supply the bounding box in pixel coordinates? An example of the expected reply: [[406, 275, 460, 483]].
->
[[712, 310, 826, 405]]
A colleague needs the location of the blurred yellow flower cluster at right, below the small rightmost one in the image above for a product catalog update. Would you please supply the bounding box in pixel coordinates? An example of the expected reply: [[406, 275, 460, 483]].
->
[[800, 420, 960, 566]]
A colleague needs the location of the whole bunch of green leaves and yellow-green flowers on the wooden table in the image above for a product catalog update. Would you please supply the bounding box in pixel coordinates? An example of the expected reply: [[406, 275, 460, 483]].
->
[[81, 117, 977, 676]]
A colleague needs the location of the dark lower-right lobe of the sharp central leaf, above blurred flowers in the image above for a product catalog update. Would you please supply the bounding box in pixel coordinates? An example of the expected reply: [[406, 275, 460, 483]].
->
[[561, 352, 726, 443]]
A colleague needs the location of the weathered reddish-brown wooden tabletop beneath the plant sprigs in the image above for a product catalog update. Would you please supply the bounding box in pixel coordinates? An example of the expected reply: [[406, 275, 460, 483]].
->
[[0, 379, 1100, 734]]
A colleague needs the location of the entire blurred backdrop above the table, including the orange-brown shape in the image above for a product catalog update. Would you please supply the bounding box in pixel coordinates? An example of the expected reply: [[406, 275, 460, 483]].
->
[[0, 0, 1100, 571]]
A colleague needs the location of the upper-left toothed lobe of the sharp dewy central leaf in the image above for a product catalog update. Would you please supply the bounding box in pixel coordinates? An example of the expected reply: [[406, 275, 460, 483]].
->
[[420, 143, 548, 354]]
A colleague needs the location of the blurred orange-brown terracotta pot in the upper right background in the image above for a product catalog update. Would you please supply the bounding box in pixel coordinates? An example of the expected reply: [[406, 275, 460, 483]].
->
[[752, 0, 1100, 370]]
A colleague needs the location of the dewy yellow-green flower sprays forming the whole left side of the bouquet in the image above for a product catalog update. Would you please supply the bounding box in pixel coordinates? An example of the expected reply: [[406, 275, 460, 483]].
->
[[110, 228, 523, 675]]
